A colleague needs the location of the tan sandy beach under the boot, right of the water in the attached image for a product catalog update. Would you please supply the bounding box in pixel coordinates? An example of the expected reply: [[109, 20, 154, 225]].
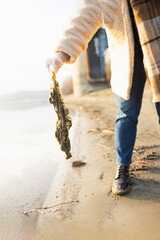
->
[[34, 84, 160, 240]]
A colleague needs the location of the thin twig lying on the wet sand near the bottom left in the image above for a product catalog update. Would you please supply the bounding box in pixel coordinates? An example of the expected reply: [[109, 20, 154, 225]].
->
[[22, 200, 79, 217]]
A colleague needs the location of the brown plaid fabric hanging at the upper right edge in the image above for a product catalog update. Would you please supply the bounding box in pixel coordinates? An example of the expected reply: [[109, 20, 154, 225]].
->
[[130, 0, 160, 102]]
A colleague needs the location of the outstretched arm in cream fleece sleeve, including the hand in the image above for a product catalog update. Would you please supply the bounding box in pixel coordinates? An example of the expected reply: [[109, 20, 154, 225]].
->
[[47, 0, 121, 72]]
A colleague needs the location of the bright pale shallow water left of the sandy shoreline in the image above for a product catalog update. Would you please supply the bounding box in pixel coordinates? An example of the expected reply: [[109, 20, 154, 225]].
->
[[0, 102, 72, 240]]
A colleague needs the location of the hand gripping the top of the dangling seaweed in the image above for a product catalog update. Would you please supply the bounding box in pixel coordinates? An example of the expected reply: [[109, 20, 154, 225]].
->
[[46, 52, 69, 73]]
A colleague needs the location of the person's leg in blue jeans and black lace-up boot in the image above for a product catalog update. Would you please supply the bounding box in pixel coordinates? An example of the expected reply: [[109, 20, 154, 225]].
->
[[112, 28, 146, 194]]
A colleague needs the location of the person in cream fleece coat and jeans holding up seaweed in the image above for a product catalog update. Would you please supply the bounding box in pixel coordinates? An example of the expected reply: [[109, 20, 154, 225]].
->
[[47, 0, 160, 195]]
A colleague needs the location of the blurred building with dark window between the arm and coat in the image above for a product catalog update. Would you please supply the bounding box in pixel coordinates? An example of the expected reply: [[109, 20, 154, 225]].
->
[[73, 26, 109, 96]]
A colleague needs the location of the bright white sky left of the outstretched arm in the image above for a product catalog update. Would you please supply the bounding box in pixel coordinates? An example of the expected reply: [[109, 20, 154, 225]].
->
[[0, 0, 81, 95]]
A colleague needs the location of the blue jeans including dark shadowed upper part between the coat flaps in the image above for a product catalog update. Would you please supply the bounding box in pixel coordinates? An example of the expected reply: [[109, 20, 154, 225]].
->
[[115, 27, 160, 166]]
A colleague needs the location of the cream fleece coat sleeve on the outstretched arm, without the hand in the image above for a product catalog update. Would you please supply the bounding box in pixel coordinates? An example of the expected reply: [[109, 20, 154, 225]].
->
[[55, 0, 102, 63]]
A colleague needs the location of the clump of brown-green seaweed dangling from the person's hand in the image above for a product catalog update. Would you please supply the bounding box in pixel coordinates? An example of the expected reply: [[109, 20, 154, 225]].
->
[[49, 73, 72, 159]]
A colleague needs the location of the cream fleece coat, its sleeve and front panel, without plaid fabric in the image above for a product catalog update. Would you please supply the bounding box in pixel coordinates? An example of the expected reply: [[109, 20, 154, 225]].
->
[[55, 0, 160, 100]]
